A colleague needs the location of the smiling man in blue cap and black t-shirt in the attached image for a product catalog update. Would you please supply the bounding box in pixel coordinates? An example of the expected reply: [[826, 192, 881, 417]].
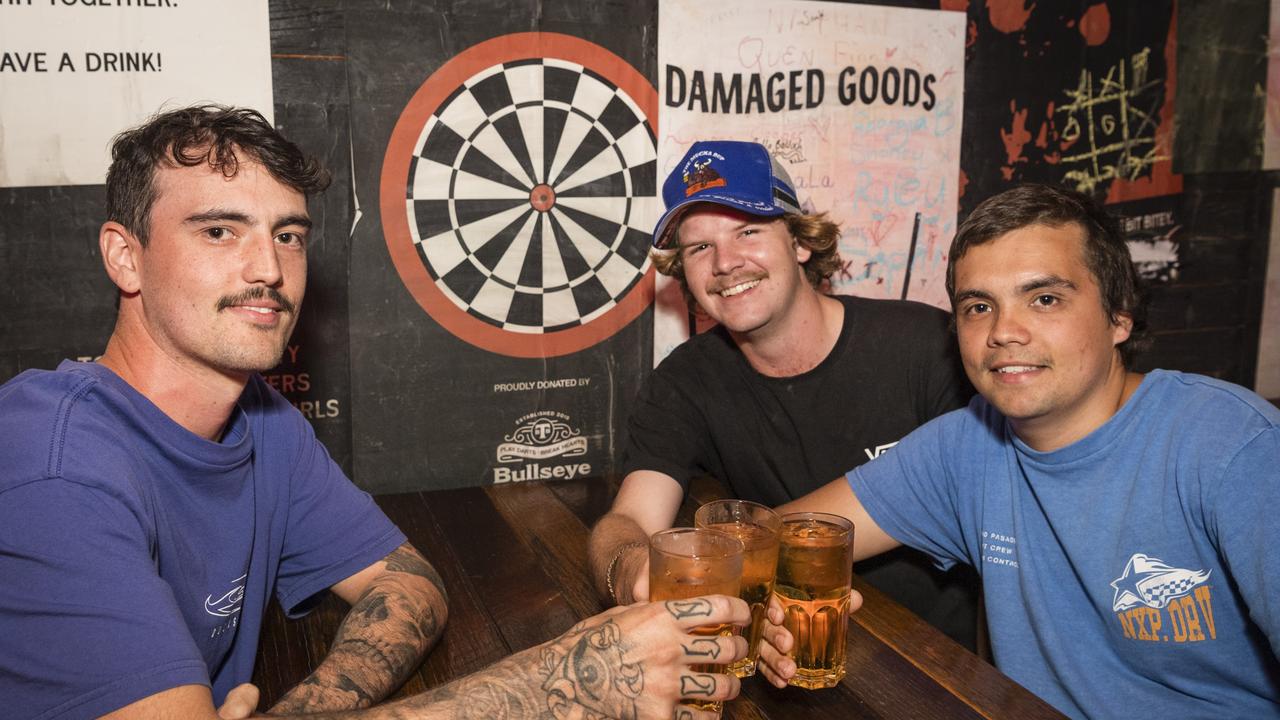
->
[[591, 141, 977, 647]]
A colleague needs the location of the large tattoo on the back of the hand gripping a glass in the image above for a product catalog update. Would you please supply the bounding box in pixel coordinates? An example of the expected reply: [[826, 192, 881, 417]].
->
[[541, 620, 644, 720]]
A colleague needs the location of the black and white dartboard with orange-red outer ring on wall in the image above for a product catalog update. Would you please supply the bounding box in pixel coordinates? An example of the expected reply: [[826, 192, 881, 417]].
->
[[380, 33, 658, 357]]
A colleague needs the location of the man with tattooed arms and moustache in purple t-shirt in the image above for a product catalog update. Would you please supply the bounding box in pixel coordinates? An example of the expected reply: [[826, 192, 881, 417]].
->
[[0, 106, 749, 720]]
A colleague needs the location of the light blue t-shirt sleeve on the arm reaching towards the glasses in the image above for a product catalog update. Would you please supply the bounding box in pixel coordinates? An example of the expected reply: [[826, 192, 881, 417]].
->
[[846, 410, 969, 570]]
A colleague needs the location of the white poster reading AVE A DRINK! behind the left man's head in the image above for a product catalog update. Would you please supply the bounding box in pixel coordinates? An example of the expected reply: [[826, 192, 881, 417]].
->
[[0, 0, 271, 187]]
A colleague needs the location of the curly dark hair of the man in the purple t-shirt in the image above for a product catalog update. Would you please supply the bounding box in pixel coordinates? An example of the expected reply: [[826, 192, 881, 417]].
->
[[106, 105, 329, 247]]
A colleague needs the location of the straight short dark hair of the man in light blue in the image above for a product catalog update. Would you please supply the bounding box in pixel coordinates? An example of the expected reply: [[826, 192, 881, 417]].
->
[[947, 184, 1149, 368]]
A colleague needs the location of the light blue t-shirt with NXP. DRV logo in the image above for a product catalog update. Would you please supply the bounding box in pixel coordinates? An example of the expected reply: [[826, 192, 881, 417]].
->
[[849, 370, 1280, 717]]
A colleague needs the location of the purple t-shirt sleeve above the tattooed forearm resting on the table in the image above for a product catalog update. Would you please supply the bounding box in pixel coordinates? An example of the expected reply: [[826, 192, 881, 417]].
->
[[275, 407, 404, 618]]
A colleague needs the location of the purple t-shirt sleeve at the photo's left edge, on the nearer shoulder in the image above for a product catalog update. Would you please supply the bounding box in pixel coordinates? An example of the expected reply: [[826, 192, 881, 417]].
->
[[0, 479, 209, 717]]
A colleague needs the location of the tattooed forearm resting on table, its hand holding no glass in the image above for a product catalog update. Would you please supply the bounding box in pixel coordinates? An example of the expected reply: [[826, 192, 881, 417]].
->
[[270, 544, 448, 715]]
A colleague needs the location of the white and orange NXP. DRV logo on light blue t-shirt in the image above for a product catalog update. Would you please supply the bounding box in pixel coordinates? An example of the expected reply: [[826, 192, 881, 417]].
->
[[1111, 552, 1217, 643]]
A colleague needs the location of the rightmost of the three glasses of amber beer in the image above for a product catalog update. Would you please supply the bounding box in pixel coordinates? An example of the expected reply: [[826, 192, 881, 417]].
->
[[773, 512, 854, 689]]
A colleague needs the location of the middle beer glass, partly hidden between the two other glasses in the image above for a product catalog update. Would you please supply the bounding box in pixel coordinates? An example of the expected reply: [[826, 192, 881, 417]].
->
[[694, 500, 782, 678]]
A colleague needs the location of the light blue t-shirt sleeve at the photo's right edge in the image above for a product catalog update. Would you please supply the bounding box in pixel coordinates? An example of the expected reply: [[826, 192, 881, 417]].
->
[[1210, 427, 1280, 657]]
